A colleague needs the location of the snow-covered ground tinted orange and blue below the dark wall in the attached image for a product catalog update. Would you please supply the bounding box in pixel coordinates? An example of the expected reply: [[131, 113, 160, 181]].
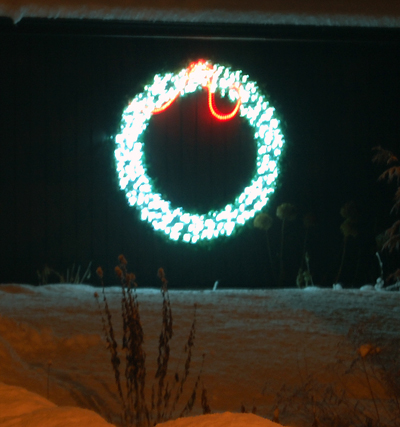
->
[[0, 284, 400, 427]]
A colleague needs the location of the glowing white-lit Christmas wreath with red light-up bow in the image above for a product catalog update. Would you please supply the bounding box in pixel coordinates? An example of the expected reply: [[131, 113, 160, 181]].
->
[[115, 60, 284, 243]]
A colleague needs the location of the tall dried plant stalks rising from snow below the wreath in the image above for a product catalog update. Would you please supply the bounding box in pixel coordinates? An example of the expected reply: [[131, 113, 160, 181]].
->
[[95, 255, 211, 427]]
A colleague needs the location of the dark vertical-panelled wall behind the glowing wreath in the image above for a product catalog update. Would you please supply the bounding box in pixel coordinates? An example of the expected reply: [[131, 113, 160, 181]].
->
[[0, 21, 400, 288]]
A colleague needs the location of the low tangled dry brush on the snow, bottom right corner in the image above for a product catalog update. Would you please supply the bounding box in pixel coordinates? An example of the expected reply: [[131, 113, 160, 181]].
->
[[273, 318, 400, 427]]
